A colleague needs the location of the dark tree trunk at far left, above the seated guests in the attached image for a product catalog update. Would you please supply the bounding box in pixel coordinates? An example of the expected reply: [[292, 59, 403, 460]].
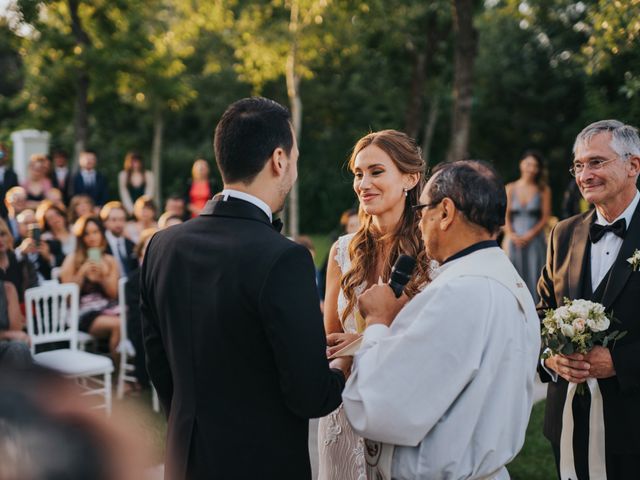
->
[[68, 0, 91, 167]]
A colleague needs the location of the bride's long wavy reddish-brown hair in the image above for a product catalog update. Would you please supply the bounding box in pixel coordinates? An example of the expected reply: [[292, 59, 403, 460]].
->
[[340, 130, 429, 325]]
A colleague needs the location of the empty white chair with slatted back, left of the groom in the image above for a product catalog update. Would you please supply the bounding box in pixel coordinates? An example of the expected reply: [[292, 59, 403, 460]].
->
[[24, 283, 113, 415]]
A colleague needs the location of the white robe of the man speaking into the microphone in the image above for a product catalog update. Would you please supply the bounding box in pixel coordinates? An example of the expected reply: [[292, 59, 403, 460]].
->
[[343, 247, 540, 480]]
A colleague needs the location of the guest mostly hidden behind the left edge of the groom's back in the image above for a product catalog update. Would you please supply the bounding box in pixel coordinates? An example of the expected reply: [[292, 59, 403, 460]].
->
[[125, 228, 158, 387]]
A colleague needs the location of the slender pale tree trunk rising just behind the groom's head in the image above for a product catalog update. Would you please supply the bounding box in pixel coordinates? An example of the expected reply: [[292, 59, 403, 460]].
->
[[286, 0, 302, 237]]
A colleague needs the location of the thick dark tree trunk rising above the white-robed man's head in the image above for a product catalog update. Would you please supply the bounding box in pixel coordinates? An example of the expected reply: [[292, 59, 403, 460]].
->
[[447, 0, 478, 161]]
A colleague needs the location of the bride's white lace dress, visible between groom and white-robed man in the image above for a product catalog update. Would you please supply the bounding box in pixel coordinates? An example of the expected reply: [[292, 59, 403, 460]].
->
[[318, 234, 367, 480]]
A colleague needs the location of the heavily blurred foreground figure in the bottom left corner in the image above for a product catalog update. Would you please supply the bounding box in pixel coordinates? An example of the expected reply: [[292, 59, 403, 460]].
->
[[0, 367, 146, 480]]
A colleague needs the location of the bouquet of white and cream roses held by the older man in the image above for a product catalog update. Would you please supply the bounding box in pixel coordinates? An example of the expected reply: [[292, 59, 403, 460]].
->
[[541, 298, 627, 394]]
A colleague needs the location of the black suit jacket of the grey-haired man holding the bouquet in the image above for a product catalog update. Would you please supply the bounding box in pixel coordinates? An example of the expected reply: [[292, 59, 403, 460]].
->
[[538, 202, 640, 454]]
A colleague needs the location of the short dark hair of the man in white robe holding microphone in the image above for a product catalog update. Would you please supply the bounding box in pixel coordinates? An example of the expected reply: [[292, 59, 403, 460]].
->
[[429, 160, 507, 234]]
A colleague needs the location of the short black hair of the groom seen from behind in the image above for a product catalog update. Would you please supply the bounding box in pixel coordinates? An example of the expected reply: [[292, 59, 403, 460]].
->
[[213, 97, 293, 184]]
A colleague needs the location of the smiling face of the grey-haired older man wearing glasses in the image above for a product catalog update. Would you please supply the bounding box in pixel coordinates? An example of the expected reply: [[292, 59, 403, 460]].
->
[[574, 132, 635, 205]]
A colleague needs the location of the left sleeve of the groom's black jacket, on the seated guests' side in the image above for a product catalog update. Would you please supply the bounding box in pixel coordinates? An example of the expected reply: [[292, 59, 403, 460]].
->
[[140, 238, 173, 417]]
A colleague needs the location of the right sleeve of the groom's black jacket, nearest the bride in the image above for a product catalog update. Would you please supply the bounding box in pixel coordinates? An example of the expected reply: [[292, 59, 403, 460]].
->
[[259, 245, 345, 418]]
